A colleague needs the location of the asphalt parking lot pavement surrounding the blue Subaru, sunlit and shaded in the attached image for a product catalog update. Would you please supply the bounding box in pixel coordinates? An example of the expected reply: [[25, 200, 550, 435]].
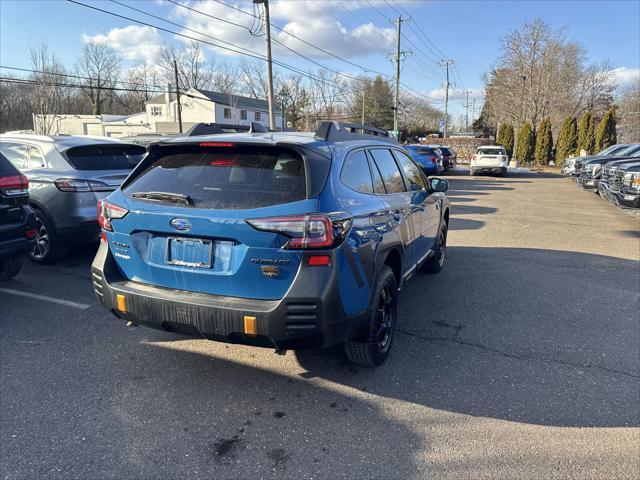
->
[[0, 170, 640, 479]]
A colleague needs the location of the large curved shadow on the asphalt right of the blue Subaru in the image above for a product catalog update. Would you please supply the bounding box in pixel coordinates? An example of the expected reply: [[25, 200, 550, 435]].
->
[[296, 247, 640, 427]]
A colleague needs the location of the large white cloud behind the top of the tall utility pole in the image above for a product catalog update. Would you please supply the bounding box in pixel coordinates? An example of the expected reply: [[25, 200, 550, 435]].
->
[[172, 0, 394, 59]]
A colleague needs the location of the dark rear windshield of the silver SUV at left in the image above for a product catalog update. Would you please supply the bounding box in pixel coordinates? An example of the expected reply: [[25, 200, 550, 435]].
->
[[65, 144, 146, 170]]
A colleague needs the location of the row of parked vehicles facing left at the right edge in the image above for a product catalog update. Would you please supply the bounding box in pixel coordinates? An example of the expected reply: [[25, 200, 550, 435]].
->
[[562, 144, 640, 209]]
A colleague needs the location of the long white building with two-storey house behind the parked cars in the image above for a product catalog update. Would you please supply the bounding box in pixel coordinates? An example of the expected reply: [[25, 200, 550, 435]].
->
[[33, 89, 282, 137]]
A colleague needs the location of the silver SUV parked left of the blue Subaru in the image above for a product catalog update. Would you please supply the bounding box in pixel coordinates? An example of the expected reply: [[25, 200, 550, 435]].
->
[[0, 134, 146, 263]]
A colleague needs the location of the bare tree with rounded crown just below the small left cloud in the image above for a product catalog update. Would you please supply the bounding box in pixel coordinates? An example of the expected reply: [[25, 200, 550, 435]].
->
[[76, 41, 120, 115]]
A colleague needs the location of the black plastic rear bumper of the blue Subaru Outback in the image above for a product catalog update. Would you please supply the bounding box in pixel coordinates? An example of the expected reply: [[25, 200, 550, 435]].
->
[[91, 242, 366, 350]]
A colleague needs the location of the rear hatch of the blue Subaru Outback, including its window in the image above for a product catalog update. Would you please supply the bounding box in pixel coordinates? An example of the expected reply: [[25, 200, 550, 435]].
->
[[108, 142, 329, 299]]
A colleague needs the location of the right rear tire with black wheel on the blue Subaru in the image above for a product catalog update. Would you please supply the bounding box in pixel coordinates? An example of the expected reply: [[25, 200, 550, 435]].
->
[[344, 265, 398, 367]]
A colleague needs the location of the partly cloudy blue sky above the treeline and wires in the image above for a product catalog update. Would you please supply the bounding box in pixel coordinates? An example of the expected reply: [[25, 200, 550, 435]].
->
[[0, 0, 640, 117]]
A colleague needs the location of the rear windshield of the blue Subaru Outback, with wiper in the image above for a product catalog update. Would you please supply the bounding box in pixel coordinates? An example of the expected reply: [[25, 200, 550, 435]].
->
[[124, 145, 307, 210]]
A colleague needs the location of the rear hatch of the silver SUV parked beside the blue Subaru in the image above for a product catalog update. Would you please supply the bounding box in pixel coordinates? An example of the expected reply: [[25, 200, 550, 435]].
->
[[64, 143, 146, 200]]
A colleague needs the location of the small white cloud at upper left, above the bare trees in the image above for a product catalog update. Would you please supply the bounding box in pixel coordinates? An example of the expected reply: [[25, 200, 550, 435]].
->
[[82, 25, 162, 63]]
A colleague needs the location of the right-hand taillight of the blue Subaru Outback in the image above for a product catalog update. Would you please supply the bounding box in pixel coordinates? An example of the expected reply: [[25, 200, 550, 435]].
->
[[246, 214, 351, 249]]
